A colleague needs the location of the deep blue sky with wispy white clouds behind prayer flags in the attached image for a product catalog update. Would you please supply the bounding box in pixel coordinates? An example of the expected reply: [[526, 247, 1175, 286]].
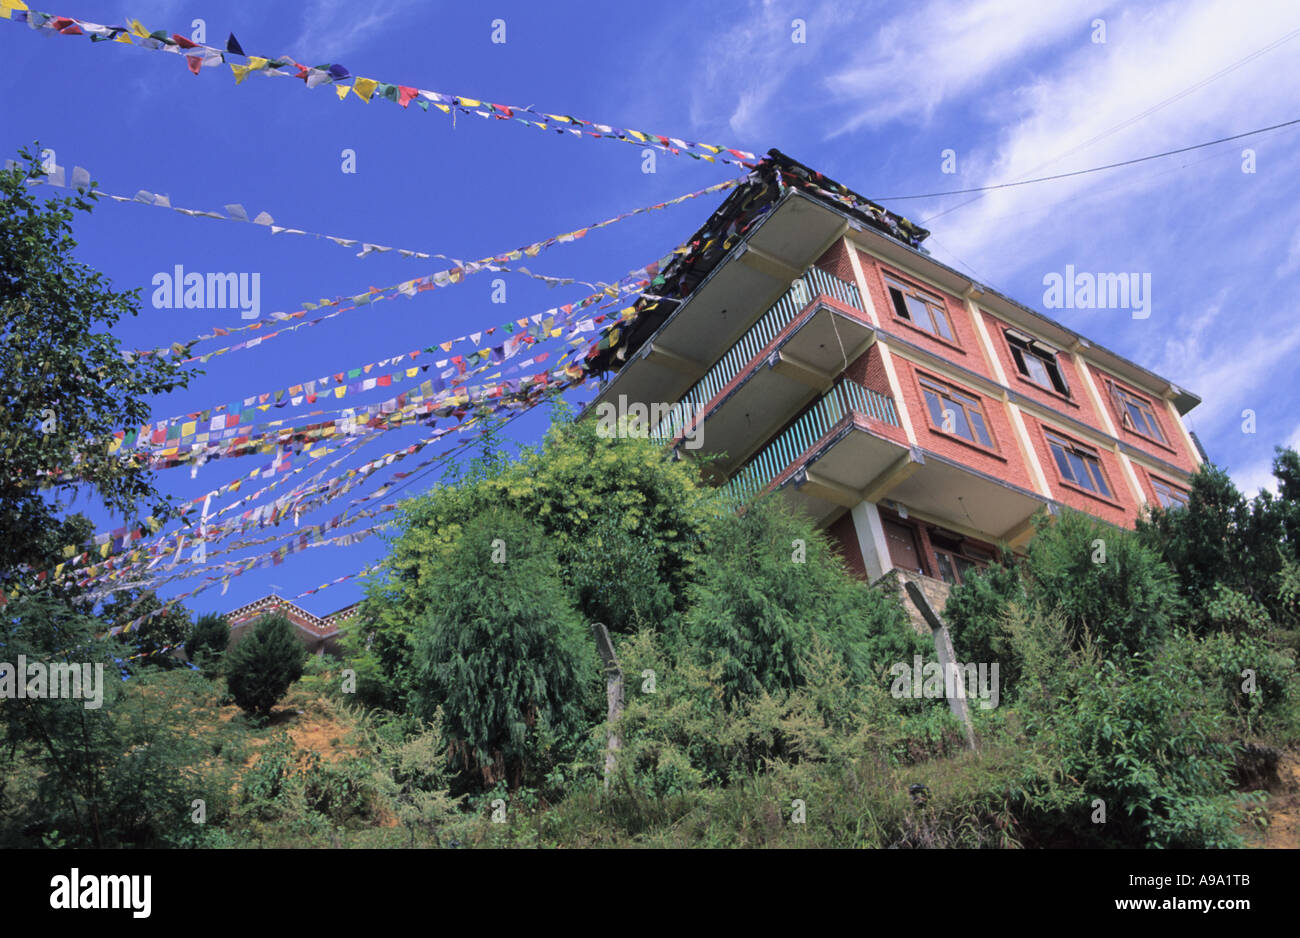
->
[[0, 0, 1300, 615]]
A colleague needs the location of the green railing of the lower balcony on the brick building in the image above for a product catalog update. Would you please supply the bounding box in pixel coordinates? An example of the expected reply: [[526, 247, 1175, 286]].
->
[[723, 378, 900, 503]]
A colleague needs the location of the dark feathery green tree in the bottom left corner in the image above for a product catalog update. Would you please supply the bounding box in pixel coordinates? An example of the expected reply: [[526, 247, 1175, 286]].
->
[[0, 595, 229, 847]]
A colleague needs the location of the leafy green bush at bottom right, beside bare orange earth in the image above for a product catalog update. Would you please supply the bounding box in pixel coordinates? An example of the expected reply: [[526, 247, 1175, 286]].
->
[[1010, 609, 1240, 847]]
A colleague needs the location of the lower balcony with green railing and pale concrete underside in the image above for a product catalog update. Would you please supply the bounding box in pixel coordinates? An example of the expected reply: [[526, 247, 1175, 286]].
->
[[723, 379, 910, 521]]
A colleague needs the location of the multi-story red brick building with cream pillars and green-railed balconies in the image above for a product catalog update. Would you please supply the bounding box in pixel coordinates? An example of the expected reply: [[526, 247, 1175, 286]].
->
[[588, 151, 1204, 618]]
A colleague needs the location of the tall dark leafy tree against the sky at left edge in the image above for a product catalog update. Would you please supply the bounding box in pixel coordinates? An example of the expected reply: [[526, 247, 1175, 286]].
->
[[0, 144, 192, 589]]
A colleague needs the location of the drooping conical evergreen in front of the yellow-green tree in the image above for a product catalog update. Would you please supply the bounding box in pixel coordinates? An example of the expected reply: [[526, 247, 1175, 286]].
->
[[412, 509, 597, 787]]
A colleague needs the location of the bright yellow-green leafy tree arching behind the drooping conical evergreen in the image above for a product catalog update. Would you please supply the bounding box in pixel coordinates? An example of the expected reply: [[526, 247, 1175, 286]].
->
[[363, 407, 719, 708]]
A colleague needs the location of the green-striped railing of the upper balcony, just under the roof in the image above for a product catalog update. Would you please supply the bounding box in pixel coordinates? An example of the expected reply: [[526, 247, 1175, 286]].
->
[[650, 261, 862, 443]]
